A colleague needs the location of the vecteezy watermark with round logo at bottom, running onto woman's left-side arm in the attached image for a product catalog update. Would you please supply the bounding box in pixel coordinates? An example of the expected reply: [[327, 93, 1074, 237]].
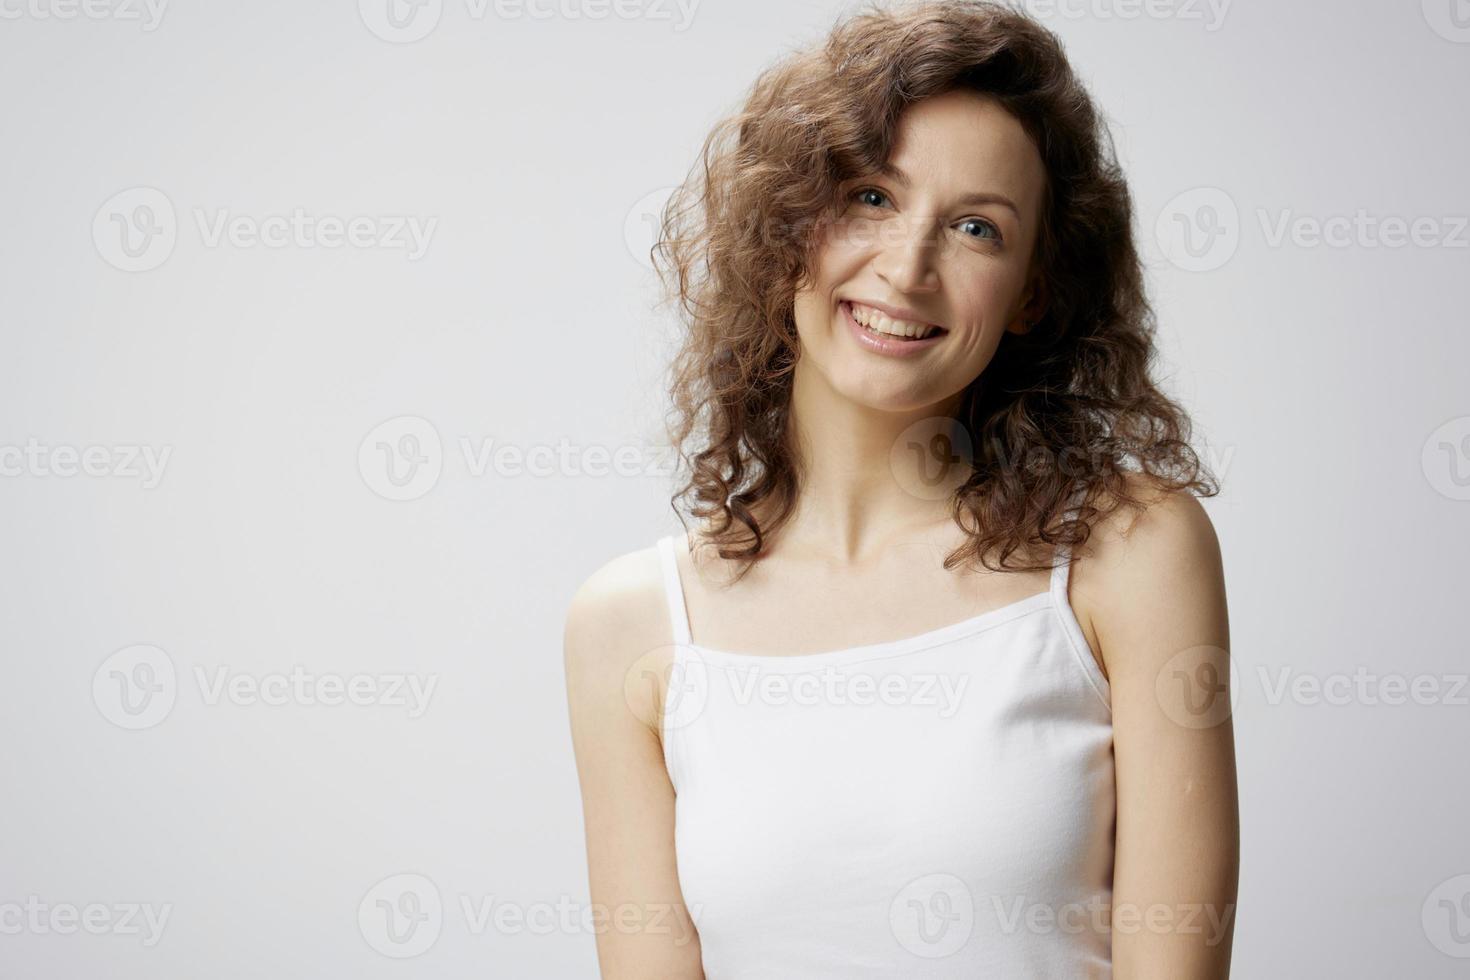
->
[[357, 873, 703, 959]]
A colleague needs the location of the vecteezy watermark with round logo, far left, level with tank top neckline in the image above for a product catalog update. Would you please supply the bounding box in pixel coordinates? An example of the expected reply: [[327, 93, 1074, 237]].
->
[[93, 644, 440, 732]]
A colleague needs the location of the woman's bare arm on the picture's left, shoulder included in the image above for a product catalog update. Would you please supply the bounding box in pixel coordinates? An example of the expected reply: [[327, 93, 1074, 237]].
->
[[563, 551, 704, 980]]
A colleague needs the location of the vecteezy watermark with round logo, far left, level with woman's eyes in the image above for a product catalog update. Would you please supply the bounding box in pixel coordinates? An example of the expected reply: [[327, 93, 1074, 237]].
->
[[93, 187, 440, 272]]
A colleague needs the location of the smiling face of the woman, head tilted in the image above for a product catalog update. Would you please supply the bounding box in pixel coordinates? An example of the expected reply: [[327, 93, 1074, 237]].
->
[[794, 90, 1045, 411]]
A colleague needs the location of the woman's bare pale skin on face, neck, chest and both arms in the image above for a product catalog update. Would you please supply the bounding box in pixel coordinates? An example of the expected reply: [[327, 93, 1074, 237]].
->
[[564, 91, 1239, 980]]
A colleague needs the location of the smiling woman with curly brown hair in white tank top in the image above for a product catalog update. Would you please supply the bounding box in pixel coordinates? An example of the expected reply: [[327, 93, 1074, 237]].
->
[[564, 1, 1238, 980]]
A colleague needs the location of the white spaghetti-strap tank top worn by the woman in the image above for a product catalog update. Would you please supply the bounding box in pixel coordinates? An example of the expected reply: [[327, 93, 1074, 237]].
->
[[659, 525, 1116, 980]]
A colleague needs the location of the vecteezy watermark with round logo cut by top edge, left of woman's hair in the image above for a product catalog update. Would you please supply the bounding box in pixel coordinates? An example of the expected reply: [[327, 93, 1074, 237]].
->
[[357, 0, 700, 44]]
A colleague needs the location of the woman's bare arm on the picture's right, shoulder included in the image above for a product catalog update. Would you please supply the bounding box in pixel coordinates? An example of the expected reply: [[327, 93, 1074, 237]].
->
[[1079, 492, 1239, 980]]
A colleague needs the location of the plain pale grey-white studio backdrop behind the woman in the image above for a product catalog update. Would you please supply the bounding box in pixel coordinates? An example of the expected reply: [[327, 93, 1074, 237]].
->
[[0, 0, 1470, 980]]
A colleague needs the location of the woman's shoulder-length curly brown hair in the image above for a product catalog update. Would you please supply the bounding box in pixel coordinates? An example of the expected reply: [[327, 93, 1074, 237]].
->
[[651, 0, 1219, 574]]
